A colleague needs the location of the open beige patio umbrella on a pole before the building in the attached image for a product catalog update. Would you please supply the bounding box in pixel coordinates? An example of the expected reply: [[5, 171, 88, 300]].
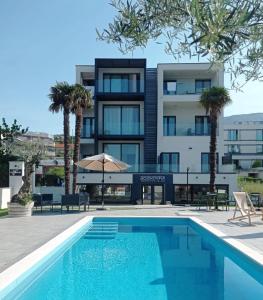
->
[[76, 153, 130, 207]]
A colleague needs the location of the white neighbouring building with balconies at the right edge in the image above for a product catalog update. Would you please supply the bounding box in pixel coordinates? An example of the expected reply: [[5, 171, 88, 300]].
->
[[224, 114, 263, 170]]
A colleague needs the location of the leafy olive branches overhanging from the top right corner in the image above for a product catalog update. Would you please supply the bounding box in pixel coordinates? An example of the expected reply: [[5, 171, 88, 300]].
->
[[97, 0, 263, 87]]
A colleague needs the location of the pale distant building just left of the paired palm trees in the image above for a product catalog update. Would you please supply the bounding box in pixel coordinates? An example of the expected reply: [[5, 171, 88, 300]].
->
[[19, 131, 55, 158]]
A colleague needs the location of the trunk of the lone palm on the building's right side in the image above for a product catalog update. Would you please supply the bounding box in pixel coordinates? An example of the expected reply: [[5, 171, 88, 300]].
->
[[209, 112, 217, 193]]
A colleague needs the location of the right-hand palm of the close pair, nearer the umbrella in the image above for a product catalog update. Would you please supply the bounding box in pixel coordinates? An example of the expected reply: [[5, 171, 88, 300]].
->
[[71, 84, 92, 194]]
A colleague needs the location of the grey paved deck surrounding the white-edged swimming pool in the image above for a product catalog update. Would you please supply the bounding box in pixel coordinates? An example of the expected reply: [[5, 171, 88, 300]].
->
[[0, 206, 263, 272]]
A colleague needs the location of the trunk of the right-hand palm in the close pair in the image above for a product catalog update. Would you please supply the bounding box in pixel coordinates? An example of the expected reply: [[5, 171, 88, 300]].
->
[[72, 108, 82, 194]]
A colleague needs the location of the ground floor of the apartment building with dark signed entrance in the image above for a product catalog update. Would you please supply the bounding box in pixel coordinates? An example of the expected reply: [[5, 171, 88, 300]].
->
[[77, 172, 237, 205]]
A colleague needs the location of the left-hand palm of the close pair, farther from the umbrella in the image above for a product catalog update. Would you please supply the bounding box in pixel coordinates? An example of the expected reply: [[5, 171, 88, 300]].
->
[[49, 82, 74, 195]]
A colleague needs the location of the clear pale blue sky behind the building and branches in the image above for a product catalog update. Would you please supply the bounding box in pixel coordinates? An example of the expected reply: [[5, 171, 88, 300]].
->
[[0, 0, 263, 134]]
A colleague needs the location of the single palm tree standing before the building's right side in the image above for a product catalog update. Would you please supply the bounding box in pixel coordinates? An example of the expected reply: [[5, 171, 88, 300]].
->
[[200, 87, 232, 193]]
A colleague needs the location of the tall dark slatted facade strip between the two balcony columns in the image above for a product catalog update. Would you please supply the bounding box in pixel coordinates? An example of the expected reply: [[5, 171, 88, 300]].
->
[[144, 68, 157, 164]]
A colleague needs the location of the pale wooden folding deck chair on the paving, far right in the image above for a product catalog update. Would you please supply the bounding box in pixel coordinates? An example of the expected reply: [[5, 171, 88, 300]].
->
[[228, 192, 263, 225]]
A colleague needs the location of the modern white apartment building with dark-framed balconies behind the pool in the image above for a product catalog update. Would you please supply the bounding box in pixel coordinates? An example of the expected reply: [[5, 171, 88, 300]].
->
[[76, 59, 236, 204]]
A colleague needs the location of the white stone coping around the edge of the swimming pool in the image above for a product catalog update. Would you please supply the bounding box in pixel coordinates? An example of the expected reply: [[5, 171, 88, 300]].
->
[[0, 215, 263, 293]]
